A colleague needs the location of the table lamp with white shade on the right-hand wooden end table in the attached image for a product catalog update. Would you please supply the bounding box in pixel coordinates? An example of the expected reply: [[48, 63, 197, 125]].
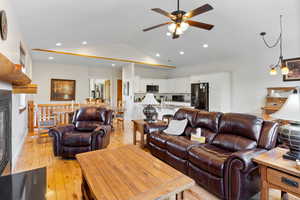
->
[[271, 87, 300, 160]]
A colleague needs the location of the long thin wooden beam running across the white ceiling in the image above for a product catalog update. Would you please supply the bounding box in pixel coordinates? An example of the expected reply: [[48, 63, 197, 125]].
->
[[32, 49, 176, 69]]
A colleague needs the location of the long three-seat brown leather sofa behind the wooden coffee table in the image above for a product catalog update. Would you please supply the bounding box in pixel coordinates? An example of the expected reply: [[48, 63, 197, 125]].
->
[[147, 109, 278, 200]]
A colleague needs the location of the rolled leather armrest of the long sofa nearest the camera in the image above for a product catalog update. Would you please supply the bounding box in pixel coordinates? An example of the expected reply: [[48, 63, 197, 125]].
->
[[224, 148, 267, 200]]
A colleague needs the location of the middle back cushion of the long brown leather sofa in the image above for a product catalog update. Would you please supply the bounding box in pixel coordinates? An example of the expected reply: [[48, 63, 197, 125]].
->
[[194, 111, 222, 133]]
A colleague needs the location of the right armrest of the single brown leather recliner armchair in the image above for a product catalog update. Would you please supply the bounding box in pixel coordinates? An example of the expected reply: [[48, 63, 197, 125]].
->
[[92, 125, 112, 150]]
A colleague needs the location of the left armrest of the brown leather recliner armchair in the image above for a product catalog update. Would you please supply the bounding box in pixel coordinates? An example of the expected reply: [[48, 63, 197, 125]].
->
[[49, 124, 75, 156]]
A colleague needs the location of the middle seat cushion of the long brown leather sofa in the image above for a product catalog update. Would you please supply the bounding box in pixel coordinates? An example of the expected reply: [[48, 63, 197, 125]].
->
[[166, 136, 199, 159]]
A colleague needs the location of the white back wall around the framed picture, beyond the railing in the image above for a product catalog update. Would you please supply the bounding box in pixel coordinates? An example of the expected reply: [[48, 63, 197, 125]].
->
[[33, 61, 121, 104]]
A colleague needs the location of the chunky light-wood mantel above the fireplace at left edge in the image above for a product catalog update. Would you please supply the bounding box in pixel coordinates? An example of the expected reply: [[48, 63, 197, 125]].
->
[[0, 53, 37, 94]]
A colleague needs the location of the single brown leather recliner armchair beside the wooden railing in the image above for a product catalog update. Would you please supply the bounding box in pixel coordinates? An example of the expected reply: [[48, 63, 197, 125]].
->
[[49, 107, 113, 158]]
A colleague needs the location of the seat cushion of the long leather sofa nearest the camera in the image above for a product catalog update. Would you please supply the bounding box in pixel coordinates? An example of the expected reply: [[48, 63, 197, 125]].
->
[[188, 144, 232, 177]]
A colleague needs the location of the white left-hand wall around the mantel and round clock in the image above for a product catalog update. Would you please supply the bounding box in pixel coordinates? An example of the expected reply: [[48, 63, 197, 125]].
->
[[0, 0, 32, 167]]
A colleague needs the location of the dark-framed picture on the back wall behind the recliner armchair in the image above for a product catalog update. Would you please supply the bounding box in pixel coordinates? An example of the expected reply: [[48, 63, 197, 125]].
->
[[50, 79, 76, 101]]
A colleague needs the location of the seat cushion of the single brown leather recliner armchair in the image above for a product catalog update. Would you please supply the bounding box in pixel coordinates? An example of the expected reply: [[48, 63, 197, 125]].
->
[[62, 132, 92, 147]]
